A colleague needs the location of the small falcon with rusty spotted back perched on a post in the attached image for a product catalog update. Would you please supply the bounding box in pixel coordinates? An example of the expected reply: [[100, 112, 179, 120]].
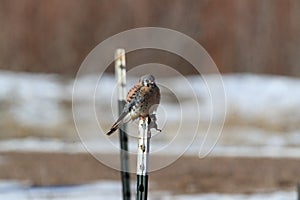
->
[[106, 75, 160, 135]]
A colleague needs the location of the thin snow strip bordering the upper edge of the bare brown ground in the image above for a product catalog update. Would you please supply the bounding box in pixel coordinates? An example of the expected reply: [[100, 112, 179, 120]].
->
[[0, 138, 300, 159]]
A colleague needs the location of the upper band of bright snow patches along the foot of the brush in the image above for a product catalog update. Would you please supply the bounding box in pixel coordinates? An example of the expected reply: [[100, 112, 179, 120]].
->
[[0, 71, 300, 124]]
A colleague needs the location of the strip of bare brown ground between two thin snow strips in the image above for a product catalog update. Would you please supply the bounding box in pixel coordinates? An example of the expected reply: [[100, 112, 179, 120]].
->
[[0, 152, 300, 193]]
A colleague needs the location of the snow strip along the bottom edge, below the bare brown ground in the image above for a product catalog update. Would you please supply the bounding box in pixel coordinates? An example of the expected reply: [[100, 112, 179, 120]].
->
[[0, 181, 296, 200]]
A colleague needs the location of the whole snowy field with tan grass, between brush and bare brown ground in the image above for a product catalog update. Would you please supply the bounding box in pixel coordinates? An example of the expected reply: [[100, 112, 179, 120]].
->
[[0, 71, 300, 157]]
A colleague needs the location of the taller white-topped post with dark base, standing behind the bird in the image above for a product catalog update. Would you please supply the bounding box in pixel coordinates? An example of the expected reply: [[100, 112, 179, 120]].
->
[[115, 49, 131, 200]]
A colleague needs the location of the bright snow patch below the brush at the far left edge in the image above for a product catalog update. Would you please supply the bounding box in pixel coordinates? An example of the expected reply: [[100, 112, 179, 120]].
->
[[0, 71, 64, 126]]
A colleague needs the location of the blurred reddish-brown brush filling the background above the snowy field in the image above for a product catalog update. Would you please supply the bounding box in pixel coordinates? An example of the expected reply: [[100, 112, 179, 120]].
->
[[0, 0, 300, 76]]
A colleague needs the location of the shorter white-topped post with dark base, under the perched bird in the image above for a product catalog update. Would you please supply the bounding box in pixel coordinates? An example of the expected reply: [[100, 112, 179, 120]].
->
[[137, 117, 151, 200]]
